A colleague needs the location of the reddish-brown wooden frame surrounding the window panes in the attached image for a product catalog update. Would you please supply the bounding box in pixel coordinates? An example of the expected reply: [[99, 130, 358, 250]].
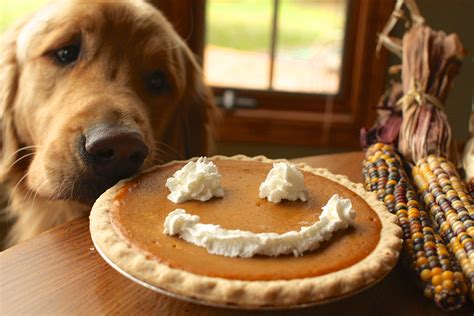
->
[[155, 0, 395, 148]]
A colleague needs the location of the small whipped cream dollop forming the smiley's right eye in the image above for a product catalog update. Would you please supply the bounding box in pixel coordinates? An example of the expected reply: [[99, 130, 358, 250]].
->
[[259, 162, 308, 203]]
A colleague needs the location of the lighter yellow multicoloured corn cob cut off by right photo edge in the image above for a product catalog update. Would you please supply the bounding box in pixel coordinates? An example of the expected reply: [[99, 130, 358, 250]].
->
[[413, 155, 474, 301]]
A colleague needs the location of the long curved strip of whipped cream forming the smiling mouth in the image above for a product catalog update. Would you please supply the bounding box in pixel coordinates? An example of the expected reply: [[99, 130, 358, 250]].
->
[[163, 194, 356, 258]]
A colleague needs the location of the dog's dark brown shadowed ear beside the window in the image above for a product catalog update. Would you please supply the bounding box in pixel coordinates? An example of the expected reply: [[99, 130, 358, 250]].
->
[[163, 47, 220, 159]]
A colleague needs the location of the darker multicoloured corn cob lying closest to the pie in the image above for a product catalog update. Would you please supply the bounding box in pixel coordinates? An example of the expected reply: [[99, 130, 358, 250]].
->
[[363, 143, 467, 310]]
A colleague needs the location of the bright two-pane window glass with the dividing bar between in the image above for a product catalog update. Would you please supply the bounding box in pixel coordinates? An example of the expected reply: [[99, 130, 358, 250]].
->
[[204, 0, 347, 94]]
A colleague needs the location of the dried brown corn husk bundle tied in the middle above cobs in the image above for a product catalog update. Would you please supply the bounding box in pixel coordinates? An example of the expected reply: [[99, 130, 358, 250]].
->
[[398, 25, 465, 162]]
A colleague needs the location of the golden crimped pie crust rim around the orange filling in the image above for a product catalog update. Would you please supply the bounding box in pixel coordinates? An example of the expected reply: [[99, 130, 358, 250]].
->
[[90, 155, 402, 308]]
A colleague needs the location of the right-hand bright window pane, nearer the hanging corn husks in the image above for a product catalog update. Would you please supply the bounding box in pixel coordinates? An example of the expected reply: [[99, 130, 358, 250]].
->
[[273, 0, 348, 94]]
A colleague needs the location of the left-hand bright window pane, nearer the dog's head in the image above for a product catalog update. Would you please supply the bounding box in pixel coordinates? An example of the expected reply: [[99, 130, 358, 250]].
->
[[204, 0, 273, 89]]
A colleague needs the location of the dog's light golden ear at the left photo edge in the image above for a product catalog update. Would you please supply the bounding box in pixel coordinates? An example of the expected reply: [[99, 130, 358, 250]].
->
[[0, 23, 23, 181]]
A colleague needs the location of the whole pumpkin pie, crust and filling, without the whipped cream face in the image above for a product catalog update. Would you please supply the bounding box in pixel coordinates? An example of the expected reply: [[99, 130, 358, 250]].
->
[[90, 155, 401, 307]]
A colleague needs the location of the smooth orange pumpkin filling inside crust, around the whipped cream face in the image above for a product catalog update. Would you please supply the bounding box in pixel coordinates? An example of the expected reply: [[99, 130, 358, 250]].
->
[[110, 160, 382, 281]]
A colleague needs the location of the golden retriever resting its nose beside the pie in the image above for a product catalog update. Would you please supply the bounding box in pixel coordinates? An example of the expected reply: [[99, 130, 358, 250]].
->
[[0, 0, 216, 244]]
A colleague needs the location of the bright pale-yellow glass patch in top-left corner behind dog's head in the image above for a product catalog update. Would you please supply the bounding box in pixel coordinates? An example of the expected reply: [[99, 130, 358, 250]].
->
[[0, 0, 49, 33]]
